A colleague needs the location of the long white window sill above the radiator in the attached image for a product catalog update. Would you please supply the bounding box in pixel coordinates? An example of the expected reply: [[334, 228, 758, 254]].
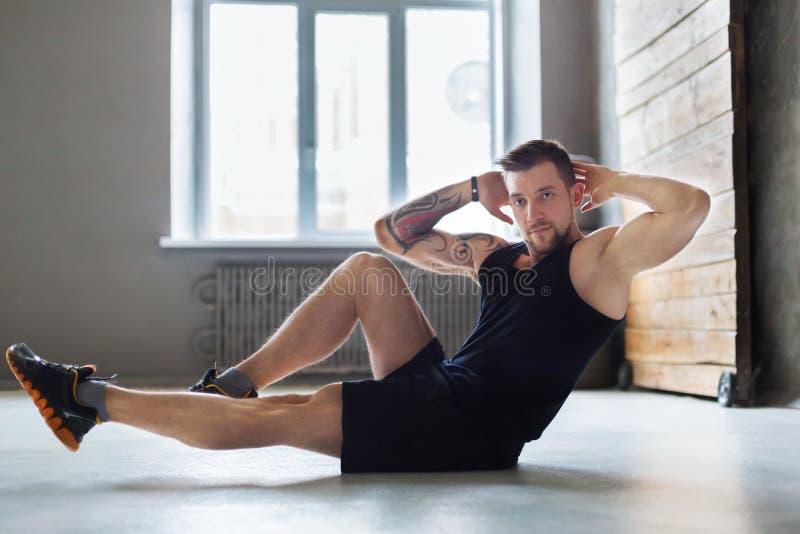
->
[[158, 236, 380, 251]]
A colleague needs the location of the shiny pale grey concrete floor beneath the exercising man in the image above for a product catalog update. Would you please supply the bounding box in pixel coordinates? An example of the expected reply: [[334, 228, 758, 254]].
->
[[0, 386, 800, 534]]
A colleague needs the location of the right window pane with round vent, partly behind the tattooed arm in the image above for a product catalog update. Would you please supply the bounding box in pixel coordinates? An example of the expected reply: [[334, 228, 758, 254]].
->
[[406, 9, 504, 235]]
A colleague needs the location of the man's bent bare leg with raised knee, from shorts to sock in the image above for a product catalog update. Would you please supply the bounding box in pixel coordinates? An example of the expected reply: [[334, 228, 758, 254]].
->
[[236, 253, 434, 388]]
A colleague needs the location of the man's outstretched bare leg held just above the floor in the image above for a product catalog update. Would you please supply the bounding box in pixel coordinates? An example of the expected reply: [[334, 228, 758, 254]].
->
[[106, 382, 342, 458]]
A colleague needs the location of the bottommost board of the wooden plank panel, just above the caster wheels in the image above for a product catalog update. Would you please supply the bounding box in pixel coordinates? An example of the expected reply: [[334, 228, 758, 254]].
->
[[631, 362, 736, 397]]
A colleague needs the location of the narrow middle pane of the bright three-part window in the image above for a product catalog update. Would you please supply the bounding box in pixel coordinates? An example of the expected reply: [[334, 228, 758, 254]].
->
[[316, 13, 389, 231]]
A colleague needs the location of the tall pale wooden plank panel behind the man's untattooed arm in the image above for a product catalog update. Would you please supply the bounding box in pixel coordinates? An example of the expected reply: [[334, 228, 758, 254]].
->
[[614, 0, 749, 402]]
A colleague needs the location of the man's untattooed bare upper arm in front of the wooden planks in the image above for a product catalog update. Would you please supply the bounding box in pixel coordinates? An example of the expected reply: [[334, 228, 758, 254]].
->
[[603, 189, 710, 278]]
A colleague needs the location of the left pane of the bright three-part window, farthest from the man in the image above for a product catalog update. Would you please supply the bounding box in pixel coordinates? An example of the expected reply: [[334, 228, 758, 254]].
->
[[209, 4, 298, 238]]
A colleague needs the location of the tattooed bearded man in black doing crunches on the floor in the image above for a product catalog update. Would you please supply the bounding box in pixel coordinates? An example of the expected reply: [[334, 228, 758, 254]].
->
[[7, 140, 709, 472]]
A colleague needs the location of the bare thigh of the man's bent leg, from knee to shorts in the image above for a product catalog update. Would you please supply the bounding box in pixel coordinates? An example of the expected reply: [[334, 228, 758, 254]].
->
[[356, 255, 436, 380]]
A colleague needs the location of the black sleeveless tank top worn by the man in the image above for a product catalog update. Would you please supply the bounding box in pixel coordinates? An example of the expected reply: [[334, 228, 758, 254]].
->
[[439, 239, 627, 442]]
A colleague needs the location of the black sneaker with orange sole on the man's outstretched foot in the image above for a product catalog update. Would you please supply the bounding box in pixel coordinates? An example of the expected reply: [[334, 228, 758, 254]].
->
[[6, 343, 117, 452]]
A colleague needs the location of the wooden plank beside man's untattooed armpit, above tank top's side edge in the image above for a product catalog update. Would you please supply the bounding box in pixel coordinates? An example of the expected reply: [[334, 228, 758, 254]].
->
[[628, 259, 736, 302]]
